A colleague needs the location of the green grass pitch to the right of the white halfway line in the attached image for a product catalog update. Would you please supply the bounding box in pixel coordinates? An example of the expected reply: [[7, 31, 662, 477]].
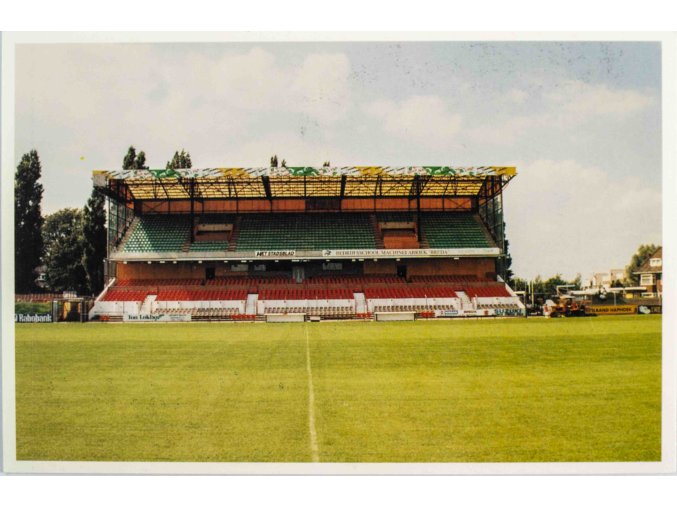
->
[[311, 317, 660, 462]]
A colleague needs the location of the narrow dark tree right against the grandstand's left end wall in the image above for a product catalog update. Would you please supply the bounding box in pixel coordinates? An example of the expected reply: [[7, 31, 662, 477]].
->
[[82, 189, 106, 294]]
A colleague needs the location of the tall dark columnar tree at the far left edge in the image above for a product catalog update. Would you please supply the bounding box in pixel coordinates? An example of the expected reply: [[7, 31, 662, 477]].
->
[[14, 150, 43, 293]]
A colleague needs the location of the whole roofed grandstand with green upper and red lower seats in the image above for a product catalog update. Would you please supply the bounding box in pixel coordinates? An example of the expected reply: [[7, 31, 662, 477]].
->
[[90, 167, 524, 321]]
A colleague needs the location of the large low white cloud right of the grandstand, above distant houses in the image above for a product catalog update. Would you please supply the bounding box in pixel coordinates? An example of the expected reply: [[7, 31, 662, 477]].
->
[[505, 160, 661, 278]]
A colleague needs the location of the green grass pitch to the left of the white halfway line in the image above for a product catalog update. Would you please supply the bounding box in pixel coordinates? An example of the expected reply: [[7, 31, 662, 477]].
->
[[16, 324, 308, 461]]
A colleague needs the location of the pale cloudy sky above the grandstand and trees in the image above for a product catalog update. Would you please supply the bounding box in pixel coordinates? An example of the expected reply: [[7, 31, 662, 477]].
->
[[15, 42, 662, 279]]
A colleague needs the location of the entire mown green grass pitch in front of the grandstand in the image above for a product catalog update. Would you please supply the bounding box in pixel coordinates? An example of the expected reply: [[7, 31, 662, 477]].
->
[[16, 316, 661, 462]]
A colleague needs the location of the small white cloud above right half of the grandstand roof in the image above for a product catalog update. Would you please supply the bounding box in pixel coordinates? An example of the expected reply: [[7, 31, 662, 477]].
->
[[365, 95, 463, 148]]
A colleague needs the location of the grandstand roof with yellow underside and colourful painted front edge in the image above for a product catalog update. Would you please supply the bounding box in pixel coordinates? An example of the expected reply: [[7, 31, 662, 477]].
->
[[93, 166, 516, 201]]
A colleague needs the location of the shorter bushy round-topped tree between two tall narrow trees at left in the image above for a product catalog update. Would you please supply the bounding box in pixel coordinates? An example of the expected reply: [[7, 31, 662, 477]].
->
[[42, 208, 88, 294]]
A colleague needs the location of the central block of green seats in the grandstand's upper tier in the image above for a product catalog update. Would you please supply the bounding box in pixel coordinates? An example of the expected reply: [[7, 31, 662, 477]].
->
[[237, 213, 376, 251]]
